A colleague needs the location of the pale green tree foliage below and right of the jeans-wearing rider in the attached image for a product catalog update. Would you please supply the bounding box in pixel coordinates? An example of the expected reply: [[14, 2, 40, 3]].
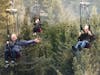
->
[[73, 14, 100, 75]]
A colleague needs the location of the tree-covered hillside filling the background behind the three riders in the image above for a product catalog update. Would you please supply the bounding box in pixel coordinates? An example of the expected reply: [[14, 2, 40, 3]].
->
[[0, 0, 100, 75]]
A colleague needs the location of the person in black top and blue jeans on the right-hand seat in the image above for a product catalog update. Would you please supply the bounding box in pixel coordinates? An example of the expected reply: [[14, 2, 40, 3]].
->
[[72, 24, 94, 52]]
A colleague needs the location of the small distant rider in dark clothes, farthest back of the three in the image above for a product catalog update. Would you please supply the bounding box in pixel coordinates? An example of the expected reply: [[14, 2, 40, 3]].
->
[[33, 17, 42, 35]]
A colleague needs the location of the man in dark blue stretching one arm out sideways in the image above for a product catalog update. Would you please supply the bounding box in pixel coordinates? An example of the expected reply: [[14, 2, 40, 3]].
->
[[5, 34, 40, 64]]
